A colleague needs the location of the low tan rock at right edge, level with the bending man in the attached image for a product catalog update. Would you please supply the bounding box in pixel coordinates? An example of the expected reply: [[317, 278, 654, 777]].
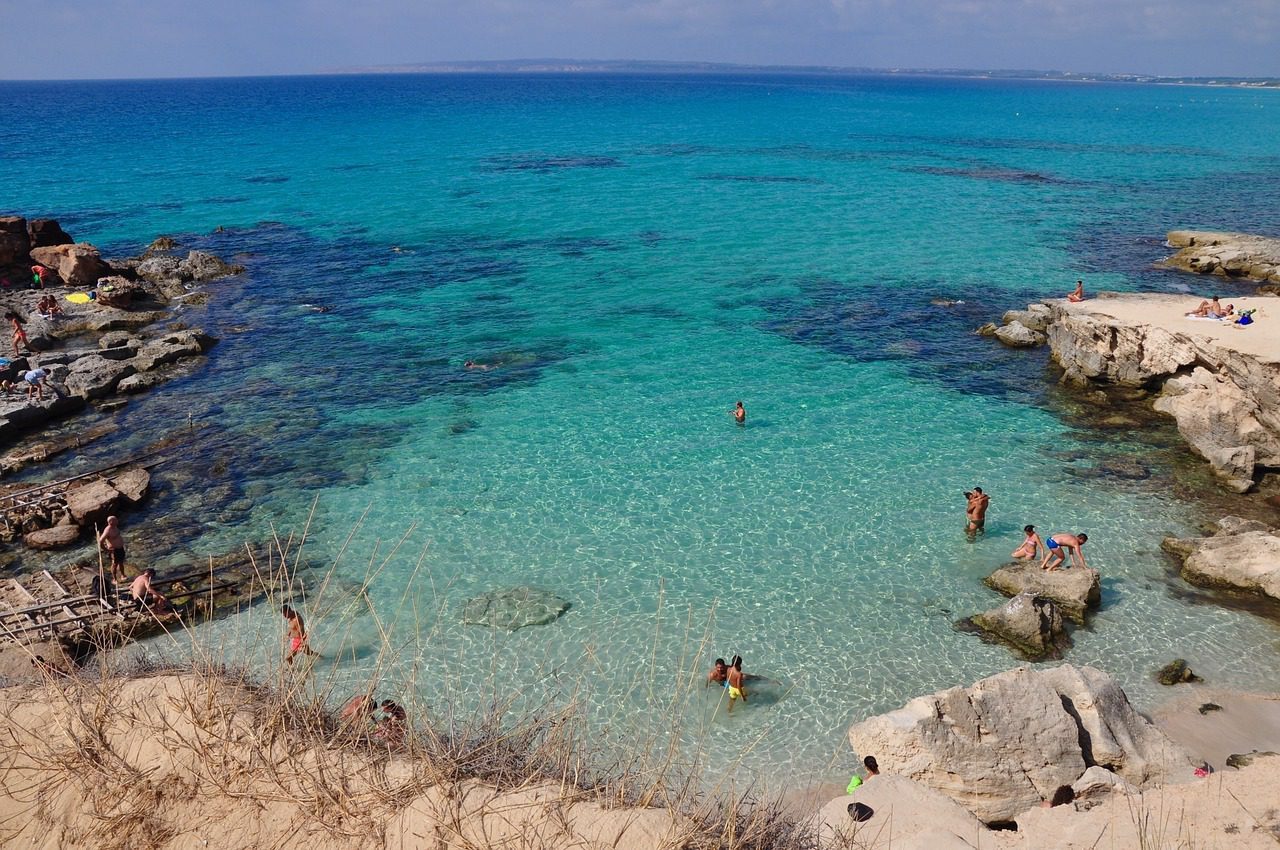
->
[[1162, 516, 1280, 600]]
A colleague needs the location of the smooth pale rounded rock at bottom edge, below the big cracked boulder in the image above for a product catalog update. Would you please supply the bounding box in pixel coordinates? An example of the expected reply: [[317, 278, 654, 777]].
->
[[814, 773, 992, 850]]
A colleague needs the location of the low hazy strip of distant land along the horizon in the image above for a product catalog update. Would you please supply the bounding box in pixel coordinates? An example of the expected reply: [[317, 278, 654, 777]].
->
[[323, 59, 1280, 88]]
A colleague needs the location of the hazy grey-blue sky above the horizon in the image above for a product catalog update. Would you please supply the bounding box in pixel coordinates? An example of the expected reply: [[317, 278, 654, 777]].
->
[[0, 0, 1280, 79]]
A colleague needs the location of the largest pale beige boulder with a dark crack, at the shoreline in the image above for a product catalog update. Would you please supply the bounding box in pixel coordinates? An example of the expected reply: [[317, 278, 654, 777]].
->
[[849, 664, 1192, 823]]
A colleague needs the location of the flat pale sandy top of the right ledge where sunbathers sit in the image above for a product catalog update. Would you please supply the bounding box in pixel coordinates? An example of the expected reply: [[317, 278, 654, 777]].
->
[[1055, 294, 1280, 362]]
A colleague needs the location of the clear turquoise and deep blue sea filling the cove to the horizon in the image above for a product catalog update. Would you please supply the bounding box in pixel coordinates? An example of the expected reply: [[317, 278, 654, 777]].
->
[[0, 76, 1280, 783]]
